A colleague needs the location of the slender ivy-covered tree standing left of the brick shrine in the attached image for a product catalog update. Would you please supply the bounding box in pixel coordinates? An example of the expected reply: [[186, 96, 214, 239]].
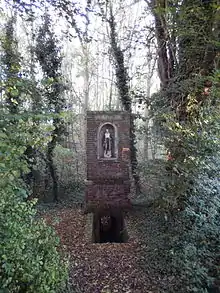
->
[[35, 12, 65, 201]]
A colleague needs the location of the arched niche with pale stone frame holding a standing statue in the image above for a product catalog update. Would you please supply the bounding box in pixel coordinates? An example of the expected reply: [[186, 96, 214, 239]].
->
[[97, 122, 118, 160]]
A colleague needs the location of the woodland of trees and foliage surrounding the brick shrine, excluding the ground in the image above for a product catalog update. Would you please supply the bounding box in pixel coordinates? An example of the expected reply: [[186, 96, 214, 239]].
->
[[0, 0, 220, 293]]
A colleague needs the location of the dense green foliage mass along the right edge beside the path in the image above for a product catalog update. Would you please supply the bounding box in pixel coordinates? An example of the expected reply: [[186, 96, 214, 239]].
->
[[154, 72, 220, 293]]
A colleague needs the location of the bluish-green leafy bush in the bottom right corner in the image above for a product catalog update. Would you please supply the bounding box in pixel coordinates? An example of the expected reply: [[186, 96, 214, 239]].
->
[[173, 160, 220, 293]]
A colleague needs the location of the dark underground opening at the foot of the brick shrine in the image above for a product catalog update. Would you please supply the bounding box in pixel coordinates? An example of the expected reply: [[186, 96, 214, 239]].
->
[[92, 211, 128, 243]]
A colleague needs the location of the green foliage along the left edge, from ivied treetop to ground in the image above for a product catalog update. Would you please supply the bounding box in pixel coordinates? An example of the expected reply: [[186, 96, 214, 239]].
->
[[0, 15, 67, 293]]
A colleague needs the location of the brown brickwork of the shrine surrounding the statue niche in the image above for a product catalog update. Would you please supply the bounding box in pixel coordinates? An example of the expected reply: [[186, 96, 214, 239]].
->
[[86, 111, 130, 209]]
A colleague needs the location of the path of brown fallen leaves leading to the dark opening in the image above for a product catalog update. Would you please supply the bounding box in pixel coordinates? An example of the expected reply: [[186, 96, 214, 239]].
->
[[45, 208, 157, 293]]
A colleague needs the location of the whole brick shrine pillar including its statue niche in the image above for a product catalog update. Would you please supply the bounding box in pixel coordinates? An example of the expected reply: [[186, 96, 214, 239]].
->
[[85, 111, 131, 242]]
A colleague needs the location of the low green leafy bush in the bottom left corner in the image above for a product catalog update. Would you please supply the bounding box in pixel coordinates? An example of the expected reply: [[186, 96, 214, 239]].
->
[[0, 184, 66, 293]]
